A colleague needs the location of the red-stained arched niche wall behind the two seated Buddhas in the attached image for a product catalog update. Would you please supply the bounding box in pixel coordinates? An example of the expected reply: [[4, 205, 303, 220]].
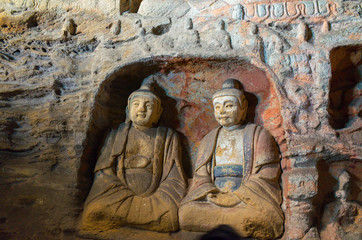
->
[[78, 57, 284, 201]]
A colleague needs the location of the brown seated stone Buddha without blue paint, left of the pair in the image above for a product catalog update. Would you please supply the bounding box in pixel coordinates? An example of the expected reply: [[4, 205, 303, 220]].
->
[[80, 85, 186, 232]]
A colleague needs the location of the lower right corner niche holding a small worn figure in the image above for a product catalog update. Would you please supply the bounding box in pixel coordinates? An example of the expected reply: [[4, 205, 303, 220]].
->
[[313, 159, 362, 240]]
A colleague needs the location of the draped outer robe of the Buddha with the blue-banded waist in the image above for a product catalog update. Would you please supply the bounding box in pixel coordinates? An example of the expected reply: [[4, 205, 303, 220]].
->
[[179, 124, 284, 239]]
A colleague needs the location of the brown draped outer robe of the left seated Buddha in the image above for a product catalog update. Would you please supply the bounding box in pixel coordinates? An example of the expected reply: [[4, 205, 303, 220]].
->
[[80, 124, 186, 232]]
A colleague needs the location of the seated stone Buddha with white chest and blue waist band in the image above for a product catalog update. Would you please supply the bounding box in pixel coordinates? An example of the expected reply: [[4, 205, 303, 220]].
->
[[179, 79, 284, 239]]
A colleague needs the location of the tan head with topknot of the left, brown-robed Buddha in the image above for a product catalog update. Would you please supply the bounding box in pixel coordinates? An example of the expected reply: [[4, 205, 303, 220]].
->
[[126, 84, 162, 128]]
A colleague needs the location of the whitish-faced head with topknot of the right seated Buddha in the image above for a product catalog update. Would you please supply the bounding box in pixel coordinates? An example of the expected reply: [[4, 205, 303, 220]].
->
[[212, 79, 248, 127]]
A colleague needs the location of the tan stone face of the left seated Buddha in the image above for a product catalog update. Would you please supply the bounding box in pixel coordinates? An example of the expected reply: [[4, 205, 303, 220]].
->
[[129, 95, 161, 127]]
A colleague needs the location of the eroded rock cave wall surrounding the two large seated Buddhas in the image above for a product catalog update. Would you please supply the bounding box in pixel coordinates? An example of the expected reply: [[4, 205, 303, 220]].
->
[[0, 0, 362, 239]]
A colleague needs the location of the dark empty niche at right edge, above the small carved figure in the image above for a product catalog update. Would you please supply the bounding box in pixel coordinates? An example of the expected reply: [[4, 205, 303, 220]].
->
[[328, 46, 362, 130]]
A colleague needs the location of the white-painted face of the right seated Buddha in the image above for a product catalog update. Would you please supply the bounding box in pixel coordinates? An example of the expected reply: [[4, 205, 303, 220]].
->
[[213, 96, 244, 127]]
